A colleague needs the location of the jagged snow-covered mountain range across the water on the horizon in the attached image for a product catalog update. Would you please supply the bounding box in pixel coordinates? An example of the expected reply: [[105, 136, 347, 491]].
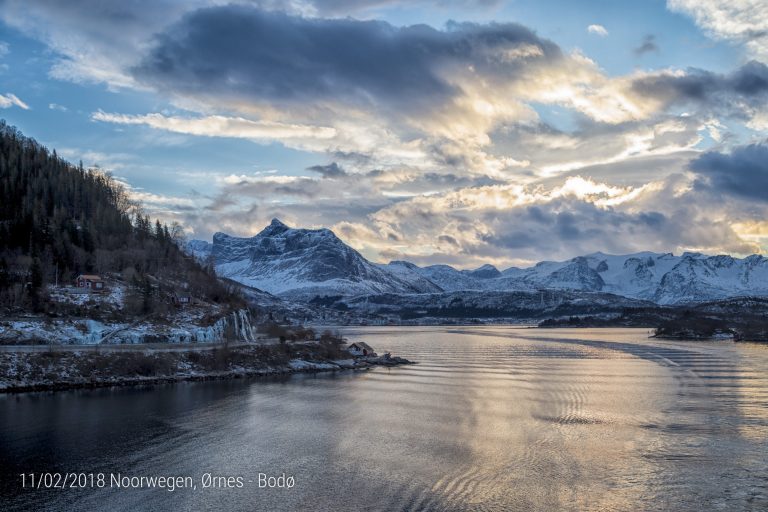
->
[[187, 219, 768, 305]]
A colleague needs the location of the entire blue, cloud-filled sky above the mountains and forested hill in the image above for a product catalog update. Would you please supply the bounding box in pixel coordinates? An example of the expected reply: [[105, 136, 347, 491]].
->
[[0, 0, 768, 268]]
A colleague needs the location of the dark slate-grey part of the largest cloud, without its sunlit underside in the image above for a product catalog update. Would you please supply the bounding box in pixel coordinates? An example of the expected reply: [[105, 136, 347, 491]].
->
[[133, 5, 561, 112]]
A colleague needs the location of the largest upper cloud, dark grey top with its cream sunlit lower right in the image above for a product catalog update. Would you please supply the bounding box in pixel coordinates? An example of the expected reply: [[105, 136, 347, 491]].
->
[[99, 5, 664, 177]]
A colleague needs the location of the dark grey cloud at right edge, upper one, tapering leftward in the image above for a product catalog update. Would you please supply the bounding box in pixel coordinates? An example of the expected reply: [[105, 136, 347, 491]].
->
[[632, 61, 768, 116]]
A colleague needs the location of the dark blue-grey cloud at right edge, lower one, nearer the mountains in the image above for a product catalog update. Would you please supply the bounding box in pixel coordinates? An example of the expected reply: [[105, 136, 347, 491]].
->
[[690, 143, 768, 202]]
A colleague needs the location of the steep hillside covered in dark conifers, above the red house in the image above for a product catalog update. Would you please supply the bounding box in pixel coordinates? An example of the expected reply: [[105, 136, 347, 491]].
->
[[0, 121, 239, 314]]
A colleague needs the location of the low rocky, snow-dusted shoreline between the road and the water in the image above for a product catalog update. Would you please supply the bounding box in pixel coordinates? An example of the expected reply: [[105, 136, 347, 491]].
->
[[0, 344, 415, 393]]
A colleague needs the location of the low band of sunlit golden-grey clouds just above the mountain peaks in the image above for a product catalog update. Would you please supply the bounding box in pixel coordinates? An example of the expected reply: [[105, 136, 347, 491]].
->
[[135, 142, 768, 267]]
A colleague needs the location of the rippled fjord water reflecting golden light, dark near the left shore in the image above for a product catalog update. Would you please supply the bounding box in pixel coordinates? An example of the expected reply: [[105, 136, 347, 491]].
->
[[0, 327, 768, 511]]
